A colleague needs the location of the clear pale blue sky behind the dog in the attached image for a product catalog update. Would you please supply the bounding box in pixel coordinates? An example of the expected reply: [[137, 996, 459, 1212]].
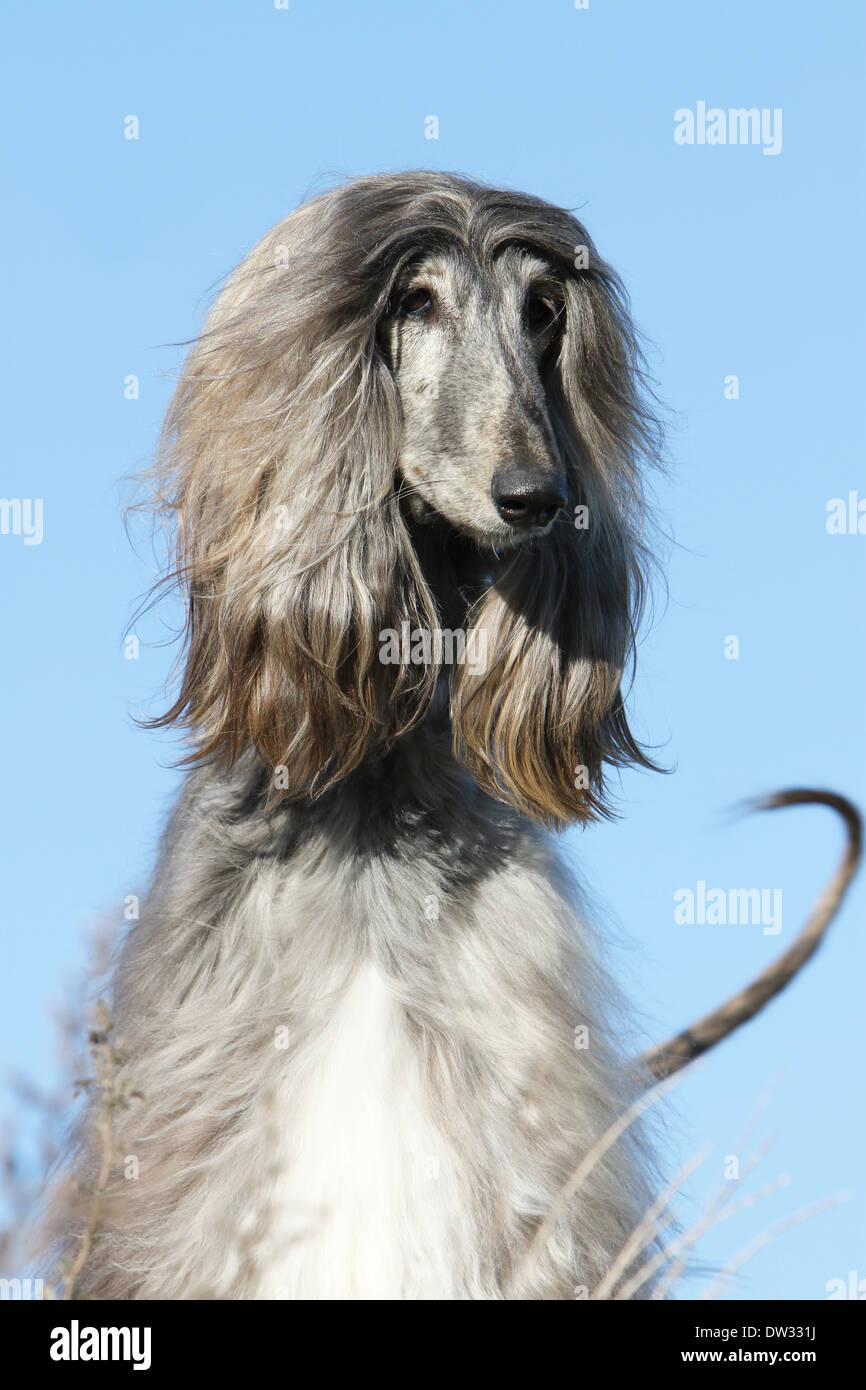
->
[[0, 0, 866, 1298]]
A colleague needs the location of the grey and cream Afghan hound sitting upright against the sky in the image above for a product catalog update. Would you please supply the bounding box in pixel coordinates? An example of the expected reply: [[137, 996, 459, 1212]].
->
[[52, 171, 861, 1300]]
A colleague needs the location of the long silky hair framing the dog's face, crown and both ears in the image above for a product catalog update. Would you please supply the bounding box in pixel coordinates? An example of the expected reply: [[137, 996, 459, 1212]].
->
[[147, 174, 657, 824]]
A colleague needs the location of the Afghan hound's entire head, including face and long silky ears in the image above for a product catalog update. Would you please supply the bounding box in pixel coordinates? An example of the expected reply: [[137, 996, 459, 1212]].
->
[[150, 171, 657, 824]]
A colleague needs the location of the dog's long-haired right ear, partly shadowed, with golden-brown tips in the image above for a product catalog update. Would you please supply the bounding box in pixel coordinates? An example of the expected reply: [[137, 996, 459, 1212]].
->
[[452, 225, 660, 827]]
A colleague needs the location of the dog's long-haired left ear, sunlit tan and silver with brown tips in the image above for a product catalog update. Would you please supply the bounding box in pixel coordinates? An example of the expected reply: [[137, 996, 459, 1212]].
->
[[146, 222, 435, 798]]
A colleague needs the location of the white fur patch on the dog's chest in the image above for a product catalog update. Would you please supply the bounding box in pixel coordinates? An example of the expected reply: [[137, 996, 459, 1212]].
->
[[256, 965, 474, 1300]]
